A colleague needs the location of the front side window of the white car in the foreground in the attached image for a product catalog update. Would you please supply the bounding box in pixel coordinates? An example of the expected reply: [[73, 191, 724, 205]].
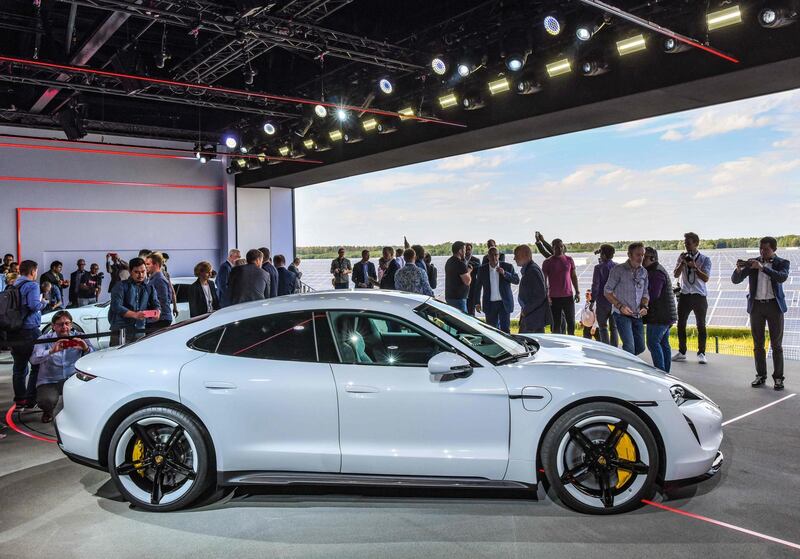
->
[[328, 311, 454, 367]]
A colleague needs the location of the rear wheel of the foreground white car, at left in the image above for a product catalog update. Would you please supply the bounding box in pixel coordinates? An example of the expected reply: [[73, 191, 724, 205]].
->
[[108, 406, 216, 512]]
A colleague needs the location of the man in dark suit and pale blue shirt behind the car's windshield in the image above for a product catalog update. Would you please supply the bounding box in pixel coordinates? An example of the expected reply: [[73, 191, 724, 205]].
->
[[476, 246, 519, 333]]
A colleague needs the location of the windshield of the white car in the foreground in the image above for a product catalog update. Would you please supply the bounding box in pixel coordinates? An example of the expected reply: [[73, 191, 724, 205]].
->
[[414, 299, 529, 364]]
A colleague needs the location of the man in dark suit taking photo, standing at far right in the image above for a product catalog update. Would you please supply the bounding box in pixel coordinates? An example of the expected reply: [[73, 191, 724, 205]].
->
[[731, 237, 789, 390]]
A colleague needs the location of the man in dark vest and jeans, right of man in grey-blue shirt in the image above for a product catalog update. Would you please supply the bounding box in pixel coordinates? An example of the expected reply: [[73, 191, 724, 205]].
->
[[642, 247, 678, 373]]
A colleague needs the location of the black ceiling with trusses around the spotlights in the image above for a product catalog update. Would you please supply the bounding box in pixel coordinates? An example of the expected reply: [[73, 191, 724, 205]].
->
[[0, 0, 800, 186]]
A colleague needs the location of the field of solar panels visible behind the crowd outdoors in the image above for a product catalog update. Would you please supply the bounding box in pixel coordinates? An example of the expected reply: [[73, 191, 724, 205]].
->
[[300, 249, 800, 360]]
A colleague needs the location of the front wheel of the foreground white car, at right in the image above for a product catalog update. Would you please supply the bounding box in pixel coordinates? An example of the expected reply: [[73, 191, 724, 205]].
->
[[541, 402, 660, 514]]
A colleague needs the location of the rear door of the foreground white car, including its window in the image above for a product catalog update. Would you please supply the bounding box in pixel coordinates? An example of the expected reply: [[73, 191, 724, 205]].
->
[[180, 311, 340, 473]]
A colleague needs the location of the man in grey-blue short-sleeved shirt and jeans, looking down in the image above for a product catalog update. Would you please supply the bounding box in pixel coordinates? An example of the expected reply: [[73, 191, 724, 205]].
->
[[604, 243, 650, 355]]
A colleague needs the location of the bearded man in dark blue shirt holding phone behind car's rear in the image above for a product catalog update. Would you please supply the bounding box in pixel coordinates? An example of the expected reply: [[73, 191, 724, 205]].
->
[[108, 258, 161, 347]]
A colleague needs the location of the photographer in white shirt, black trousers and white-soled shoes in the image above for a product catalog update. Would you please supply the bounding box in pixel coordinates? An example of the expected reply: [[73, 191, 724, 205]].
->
[[672, 233, 711, 365]]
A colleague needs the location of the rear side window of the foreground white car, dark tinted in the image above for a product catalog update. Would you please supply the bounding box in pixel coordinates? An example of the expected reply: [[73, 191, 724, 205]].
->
[[217, 311, 317, 362]]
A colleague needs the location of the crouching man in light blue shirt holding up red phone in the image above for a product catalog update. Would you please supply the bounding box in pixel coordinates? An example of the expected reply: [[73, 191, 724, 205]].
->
[[31, 311, 94, 423]]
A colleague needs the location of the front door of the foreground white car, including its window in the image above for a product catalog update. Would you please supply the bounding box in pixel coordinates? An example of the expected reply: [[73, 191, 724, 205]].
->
[[328, 311, 509, 479]]
